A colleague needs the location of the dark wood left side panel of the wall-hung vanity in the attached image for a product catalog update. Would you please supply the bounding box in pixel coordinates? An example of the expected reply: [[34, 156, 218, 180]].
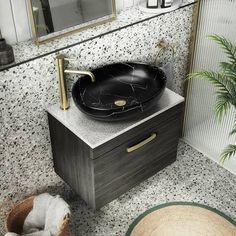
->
[[48, 114, 95, 208]]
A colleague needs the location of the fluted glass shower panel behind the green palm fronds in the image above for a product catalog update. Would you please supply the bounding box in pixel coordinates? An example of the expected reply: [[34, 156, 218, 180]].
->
[[184, 0, 236, 173]]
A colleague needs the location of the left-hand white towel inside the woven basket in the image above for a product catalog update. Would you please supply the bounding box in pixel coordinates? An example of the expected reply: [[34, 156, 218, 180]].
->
[[23, 193, 54, 234]]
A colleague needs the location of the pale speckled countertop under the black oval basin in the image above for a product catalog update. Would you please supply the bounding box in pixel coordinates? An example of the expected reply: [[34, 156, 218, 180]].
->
[[46, 88, 184, 149]]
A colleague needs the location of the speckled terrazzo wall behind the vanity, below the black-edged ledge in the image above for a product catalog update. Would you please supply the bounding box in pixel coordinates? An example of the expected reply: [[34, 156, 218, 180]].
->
[[0, 6, 193, 207]]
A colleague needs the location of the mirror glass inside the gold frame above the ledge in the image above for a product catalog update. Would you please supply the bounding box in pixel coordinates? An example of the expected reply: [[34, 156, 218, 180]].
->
[[31, 0, 115, 41]]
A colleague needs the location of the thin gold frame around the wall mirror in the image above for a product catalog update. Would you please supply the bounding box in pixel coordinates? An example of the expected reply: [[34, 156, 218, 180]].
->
[[28, 0, 117, 45]]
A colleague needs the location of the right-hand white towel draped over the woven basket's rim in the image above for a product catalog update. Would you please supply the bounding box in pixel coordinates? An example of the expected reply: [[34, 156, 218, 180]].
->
[[44, 196, 70, 236]]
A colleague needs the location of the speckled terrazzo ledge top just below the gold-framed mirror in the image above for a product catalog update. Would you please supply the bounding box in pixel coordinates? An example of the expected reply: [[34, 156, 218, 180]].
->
[[0, 0, 195, 70]]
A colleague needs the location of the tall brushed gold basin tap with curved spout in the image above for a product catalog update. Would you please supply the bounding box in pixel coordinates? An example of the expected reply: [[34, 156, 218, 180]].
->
[[56, 54, 95, 110]]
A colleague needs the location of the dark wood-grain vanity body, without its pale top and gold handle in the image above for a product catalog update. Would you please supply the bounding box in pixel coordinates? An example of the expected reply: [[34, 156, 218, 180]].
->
[[48, 103, 183, 209]]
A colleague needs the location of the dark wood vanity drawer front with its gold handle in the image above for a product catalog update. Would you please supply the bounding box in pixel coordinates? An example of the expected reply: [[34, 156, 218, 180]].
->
[[93, 104, 183, 207]]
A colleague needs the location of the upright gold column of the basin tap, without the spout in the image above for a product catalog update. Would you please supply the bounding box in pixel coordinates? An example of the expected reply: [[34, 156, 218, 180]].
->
[[56, 55, 70, 111]]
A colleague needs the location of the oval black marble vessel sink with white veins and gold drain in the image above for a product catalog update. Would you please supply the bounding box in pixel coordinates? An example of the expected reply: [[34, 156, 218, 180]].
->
[[72, 63, 166, 121]]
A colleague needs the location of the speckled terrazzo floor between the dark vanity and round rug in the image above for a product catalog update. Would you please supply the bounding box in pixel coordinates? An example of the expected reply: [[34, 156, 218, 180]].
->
[[70, 141, 236, 236]]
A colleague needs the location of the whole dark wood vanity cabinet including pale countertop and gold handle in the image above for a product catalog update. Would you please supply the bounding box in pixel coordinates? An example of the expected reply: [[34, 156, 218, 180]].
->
[[47, 89, 184, 209]]
